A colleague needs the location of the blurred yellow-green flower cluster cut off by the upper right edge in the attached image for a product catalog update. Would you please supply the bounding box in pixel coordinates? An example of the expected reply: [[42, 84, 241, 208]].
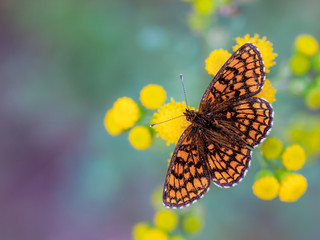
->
[[289, 34, 320, 110]]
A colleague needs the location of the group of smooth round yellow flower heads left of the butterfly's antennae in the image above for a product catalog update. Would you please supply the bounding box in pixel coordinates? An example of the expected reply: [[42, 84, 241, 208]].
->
[[104, 84, 166, 150]]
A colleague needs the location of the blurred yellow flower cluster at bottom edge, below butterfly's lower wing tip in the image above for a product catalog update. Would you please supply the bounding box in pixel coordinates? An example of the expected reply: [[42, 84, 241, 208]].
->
[[132, 188, 203, 240]]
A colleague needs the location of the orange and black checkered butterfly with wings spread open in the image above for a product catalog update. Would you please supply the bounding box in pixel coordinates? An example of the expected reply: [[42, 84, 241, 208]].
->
[[163, 43, 273, 208]]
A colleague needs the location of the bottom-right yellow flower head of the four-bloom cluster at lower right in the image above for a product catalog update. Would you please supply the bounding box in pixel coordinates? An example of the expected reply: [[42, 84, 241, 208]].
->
[[279, 173, 308, 202]]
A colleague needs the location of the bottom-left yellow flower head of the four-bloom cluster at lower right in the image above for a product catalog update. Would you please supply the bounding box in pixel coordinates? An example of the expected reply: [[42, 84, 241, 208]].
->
[[252, 170, 280, 200]]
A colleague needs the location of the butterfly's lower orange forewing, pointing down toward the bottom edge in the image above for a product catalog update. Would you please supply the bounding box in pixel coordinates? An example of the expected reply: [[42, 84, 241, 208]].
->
[[163, 125, 210, 208]]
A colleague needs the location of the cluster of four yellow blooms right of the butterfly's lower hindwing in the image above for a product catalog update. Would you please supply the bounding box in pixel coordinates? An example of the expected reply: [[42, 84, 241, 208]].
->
[[252, 137, 307, 202]]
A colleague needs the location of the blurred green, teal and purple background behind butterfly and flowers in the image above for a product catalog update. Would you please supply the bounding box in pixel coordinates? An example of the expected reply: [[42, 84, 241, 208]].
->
[[0, 0, 320, 240]]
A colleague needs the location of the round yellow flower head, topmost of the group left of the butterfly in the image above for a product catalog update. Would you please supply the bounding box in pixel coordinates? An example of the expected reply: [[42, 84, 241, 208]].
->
[[140, 84, 166, 109]]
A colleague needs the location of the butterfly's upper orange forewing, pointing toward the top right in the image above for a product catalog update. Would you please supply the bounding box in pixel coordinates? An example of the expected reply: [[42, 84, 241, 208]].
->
[[199, 43, 265, 112]]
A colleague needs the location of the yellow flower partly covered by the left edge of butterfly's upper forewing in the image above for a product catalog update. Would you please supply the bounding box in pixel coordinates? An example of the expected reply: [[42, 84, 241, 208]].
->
[[206, 49, 231, 75]]
